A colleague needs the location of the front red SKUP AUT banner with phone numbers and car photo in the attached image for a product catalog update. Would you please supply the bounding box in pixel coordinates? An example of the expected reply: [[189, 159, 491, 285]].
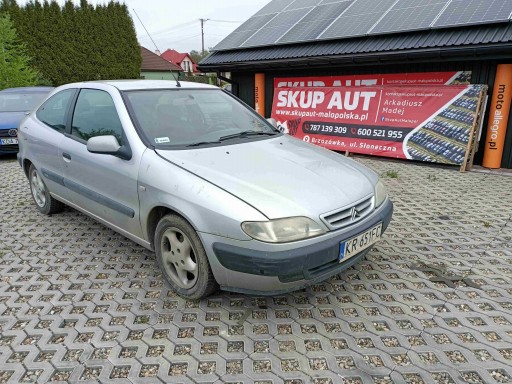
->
[[271, 85, 486, 165]]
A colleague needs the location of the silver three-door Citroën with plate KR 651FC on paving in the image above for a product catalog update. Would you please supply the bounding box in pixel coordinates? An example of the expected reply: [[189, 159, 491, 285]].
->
[[18, 80, 393, 299]]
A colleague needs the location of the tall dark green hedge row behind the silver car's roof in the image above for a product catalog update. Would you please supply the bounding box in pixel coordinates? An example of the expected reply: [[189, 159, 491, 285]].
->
[[0, 0, 142, 85]]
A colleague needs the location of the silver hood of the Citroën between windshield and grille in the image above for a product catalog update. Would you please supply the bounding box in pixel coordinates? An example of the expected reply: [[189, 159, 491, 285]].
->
[[156, 135, 377, 219]]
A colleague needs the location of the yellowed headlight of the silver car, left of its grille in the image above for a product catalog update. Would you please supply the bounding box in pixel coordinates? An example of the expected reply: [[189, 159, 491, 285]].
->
[[242, 217, 325, 243]]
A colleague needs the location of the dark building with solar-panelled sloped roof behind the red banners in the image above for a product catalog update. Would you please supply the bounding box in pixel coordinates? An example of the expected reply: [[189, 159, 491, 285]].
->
[[198, 0, 512, 168]]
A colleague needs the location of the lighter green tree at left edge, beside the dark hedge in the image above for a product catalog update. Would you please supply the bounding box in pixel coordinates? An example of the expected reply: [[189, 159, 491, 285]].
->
[[0, 13, 38, 89]]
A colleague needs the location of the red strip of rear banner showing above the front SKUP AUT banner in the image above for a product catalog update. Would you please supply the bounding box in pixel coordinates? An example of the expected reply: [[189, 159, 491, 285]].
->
[[274, 71, 471, 88]]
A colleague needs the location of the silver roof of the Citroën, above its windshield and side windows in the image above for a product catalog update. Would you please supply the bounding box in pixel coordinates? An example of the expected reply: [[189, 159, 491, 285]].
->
[[58, 79, 217, 91]]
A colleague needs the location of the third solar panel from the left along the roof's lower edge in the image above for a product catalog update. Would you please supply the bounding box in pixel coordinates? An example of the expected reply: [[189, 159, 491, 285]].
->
[[278, 1, 352, 43]]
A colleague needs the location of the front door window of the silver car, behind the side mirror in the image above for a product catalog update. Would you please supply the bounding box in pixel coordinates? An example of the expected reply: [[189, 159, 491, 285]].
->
[[71, 89, 124, 145]]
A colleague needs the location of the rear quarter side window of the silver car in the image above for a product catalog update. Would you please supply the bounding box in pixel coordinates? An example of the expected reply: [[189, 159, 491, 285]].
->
[[36, 89, 76, 132]]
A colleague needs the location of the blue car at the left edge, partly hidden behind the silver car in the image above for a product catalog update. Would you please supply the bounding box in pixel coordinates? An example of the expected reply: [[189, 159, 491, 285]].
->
[[0, 87, 53, 154]]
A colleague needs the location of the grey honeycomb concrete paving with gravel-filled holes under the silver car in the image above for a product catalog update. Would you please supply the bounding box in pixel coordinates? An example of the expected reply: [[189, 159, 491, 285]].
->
[[0, 157, 512, 384]]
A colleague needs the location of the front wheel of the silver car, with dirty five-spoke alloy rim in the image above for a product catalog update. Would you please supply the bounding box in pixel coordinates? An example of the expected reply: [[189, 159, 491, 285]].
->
[[155, 215, 219, 300]]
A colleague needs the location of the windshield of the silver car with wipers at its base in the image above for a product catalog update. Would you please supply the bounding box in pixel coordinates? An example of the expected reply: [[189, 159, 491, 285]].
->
[[125, 89, 280, 149]]
